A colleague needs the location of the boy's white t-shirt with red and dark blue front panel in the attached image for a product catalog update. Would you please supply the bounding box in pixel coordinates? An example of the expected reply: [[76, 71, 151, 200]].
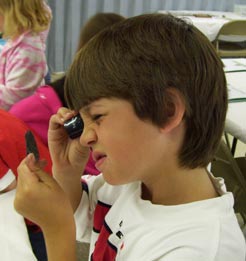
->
[[75, 175, 246, 261]]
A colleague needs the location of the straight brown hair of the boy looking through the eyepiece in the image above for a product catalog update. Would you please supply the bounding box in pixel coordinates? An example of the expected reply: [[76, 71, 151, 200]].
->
[[65, 14, 227, 168]]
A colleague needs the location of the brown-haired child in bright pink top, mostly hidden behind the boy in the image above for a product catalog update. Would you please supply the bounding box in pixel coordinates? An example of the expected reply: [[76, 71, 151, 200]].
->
[[9, 13, 125, 175]]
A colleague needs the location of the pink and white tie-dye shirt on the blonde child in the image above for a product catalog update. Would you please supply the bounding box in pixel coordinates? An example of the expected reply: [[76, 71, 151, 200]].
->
[[0, 32, 48, 110]]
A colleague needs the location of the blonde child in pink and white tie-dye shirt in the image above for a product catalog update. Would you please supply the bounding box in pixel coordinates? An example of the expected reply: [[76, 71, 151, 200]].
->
[[0, 0, 52, 110]]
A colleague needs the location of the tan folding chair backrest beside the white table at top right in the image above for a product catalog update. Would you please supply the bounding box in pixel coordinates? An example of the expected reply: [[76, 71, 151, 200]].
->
[[213, 20, 246, 57]]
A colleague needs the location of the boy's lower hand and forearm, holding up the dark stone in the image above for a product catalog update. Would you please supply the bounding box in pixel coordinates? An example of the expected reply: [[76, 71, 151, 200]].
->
[[14, 154, 76, 260]]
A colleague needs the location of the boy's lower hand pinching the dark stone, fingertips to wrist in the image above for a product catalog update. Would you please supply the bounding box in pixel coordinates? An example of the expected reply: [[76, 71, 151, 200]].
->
[[14, 154, 74, 232]]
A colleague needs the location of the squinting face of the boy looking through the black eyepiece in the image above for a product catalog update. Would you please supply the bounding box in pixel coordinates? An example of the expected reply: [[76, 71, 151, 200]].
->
[[80, 98, 165, 185]]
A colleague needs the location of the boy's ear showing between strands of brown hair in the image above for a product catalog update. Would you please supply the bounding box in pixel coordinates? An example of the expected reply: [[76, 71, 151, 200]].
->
[[162, 88, 186, 133]]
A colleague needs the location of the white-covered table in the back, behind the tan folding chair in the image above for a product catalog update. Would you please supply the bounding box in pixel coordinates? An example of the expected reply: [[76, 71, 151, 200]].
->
[[158, 10, 246, 42]]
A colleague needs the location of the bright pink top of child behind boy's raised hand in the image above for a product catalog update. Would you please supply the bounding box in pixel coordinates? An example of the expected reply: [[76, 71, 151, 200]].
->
[[9, 85, 99, 175]]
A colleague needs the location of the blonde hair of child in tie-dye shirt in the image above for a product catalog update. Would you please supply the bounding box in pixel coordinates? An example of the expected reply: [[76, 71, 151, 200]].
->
[[0, 0, 52, 38]]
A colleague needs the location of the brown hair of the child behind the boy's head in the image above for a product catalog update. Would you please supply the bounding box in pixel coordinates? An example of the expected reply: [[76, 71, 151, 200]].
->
[[77, 13, 125, 51]]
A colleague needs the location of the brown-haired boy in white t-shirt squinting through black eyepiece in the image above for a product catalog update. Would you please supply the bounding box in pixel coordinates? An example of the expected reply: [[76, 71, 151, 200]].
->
[[15, 14, 245, 261]]
